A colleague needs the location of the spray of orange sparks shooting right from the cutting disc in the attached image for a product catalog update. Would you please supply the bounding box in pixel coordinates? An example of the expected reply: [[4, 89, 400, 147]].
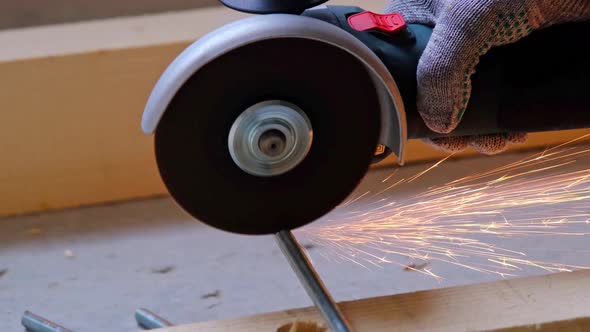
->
[[297, 134, 590, 280]]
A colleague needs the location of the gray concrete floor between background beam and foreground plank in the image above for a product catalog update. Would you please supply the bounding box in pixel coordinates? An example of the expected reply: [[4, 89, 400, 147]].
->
[[0, 147, 590, 332]]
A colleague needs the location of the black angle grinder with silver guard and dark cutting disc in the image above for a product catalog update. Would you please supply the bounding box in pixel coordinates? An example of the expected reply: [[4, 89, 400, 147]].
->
[[142, 0, 590, 234]]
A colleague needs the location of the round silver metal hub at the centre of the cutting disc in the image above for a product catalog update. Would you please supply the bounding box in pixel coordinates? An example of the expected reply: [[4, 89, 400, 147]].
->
[[228, 100, 313, 176]]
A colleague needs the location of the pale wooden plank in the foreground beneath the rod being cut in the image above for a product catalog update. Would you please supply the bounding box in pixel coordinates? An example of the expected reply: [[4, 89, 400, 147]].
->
[[161, 270, 590, 332]]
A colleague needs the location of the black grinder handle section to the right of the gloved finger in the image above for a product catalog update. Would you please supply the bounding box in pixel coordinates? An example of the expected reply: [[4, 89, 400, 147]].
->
[[444, 22, 590, 137]]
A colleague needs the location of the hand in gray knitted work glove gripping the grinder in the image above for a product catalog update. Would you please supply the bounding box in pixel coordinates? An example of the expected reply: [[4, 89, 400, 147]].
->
[[386, 0, 590, 154]]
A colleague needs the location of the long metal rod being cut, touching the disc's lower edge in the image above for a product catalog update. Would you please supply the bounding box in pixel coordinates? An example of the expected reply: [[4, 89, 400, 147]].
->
[[275, 231, 353, 332]]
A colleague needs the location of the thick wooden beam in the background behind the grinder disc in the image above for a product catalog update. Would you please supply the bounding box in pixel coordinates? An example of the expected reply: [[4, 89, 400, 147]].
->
[[0, 5, 580, 216]]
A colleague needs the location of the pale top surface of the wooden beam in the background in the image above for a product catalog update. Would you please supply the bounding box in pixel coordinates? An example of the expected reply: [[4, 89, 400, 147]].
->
[[0, 7, 248, 62]]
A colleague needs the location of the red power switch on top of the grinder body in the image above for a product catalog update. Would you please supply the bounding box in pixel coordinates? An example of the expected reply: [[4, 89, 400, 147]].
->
[[348, 11, 406, 34]]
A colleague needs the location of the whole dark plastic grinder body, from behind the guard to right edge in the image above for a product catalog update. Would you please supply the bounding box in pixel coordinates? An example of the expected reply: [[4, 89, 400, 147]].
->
[[303, 6, 590, 139]]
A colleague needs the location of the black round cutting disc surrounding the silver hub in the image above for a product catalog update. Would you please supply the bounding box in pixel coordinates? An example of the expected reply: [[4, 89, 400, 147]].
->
[[156, 38, 380, 234]]
